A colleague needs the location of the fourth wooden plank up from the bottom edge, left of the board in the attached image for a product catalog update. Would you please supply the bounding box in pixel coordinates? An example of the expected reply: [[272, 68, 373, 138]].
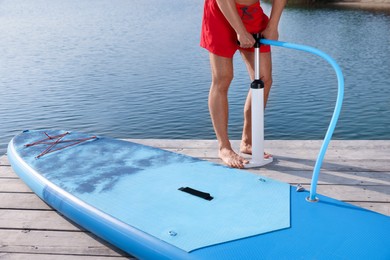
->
[[0, 193, 51, 210]]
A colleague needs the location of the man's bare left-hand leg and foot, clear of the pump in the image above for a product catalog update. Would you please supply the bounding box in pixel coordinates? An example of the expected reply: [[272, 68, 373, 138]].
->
[[209, 53, 248, 168]]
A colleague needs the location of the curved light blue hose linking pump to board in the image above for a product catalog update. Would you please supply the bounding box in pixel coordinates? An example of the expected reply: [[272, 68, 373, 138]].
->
[[260, 39, 344, 201]]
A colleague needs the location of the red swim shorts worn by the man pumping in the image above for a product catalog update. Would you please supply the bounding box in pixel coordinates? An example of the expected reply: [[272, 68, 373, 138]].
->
[[200, 0, 271, 58]]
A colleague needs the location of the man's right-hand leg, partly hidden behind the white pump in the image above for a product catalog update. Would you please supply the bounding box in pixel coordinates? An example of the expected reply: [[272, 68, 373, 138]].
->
[[240, 50, 272, 155]]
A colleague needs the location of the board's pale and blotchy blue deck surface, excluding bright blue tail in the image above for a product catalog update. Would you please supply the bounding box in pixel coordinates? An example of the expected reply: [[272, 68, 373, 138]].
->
[[13, 131, 290, 252]]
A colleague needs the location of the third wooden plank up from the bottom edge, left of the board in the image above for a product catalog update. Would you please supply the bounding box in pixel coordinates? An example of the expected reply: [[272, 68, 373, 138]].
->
[[0, 209, 80, 231]]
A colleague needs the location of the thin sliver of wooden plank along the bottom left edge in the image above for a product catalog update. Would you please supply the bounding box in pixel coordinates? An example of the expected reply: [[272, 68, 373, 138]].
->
[[0, 253, 131, 260]]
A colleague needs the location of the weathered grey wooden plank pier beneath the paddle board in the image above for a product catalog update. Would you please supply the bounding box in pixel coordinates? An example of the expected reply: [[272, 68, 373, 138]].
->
[[0, 140, 390, 260]]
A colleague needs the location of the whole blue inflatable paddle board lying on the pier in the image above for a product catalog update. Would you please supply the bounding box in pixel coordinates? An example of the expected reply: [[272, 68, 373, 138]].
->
[[8, 130, 390, 259]]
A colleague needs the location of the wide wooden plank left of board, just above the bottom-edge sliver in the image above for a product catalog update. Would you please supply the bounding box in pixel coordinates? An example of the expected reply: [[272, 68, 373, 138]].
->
[[0, 229, 131, 256]]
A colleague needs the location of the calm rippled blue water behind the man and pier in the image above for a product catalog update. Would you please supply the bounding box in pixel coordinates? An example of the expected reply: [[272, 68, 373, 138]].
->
[[0, 0, 390, 154]]
